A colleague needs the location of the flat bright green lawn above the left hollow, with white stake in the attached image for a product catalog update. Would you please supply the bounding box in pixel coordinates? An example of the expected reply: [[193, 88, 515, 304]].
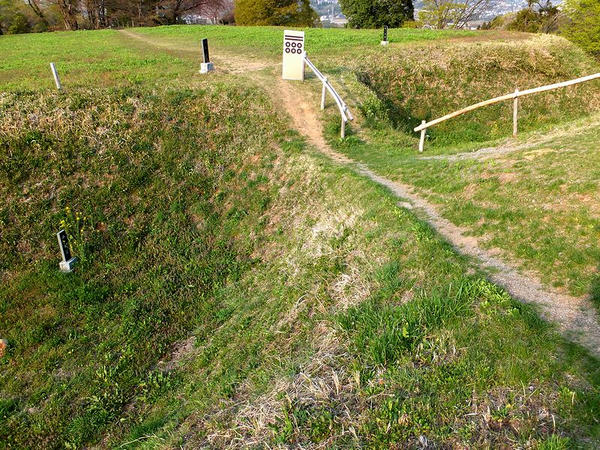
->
[[0, 30, 190, 91]]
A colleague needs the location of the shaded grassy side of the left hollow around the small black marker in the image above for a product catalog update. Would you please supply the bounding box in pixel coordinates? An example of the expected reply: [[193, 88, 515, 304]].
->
[[0, 85, 286, 447]]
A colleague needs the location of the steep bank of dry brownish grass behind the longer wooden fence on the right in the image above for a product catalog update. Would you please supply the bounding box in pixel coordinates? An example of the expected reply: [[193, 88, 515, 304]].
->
[[358, 36, 600, 148]]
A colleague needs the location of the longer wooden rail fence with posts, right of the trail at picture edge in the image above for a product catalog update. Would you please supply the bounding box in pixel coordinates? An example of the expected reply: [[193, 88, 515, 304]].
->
[[415, 73, 600, 152]]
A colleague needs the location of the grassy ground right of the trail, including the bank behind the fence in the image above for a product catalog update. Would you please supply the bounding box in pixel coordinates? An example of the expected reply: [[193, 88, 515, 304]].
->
[[314, 32, 600, 299]]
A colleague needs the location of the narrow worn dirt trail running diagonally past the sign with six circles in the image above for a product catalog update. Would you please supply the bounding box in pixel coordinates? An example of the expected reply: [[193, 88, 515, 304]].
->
[[123, 31, 600, 356]]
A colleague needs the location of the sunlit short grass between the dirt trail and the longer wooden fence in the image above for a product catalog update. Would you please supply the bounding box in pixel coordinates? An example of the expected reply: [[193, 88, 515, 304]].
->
[[328, 109, 600, 298]]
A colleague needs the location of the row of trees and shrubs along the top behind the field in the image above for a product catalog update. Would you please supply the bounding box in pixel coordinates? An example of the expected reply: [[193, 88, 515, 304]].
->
[[0, 0, 600, 57]]
